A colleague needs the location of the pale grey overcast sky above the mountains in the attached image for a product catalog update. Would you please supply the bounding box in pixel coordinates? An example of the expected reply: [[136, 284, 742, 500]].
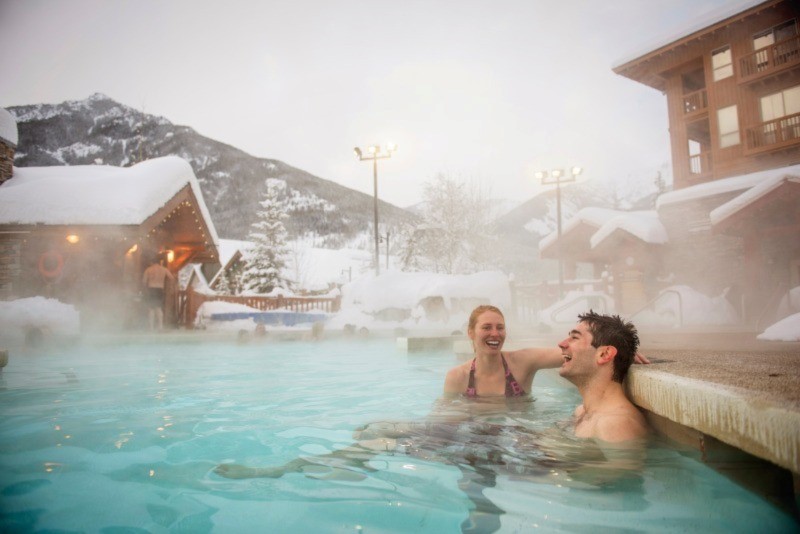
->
[[0, 0, 730, 207]]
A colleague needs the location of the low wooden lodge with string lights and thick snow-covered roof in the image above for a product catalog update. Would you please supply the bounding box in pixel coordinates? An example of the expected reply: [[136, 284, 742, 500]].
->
[[0, 109, 219, 328]]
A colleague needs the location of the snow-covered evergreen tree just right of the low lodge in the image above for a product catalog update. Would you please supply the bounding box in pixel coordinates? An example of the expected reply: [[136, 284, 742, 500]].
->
[[242, 182, 288, 294]]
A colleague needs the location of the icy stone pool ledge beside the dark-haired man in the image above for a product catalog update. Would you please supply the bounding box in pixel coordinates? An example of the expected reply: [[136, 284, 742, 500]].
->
[[626, 351, 800, 474]]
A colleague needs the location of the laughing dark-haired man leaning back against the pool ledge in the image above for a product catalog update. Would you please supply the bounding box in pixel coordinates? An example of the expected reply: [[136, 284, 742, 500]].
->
[[558, 311, 648, 443]]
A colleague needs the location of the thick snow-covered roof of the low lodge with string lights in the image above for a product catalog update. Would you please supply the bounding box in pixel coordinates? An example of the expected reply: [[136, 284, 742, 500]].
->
[[0, 156, 219, 245]]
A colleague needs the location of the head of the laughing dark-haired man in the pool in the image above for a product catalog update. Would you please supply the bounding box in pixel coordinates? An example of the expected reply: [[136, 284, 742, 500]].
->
[[559, 310, 639, 383]]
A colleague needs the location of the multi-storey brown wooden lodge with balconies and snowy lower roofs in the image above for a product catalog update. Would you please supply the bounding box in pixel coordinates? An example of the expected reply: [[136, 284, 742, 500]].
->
[[540, 0, 800, 327]]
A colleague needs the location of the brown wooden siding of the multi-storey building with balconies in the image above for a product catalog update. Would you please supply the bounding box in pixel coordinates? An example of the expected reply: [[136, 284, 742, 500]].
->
[[615, 0, 800, 189]]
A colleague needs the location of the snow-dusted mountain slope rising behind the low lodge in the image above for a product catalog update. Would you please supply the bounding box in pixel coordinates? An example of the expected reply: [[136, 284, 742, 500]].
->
[[7, 94, 416, 248]]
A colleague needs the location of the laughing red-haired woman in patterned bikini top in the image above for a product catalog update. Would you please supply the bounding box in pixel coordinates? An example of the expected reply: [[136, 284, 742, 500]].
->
[[444, 305, 650, 397]]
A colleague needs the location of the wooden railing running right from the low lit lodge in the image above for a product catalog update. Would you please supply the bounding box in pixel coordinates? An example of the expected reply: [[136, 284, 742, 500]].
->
[[178, 288, 341, 329]]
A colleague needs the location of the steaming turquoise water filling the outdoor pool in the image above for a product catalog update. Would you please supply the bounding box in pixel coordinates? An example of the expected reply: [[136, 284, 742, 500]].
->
[[0, 340, 798, 533]]
